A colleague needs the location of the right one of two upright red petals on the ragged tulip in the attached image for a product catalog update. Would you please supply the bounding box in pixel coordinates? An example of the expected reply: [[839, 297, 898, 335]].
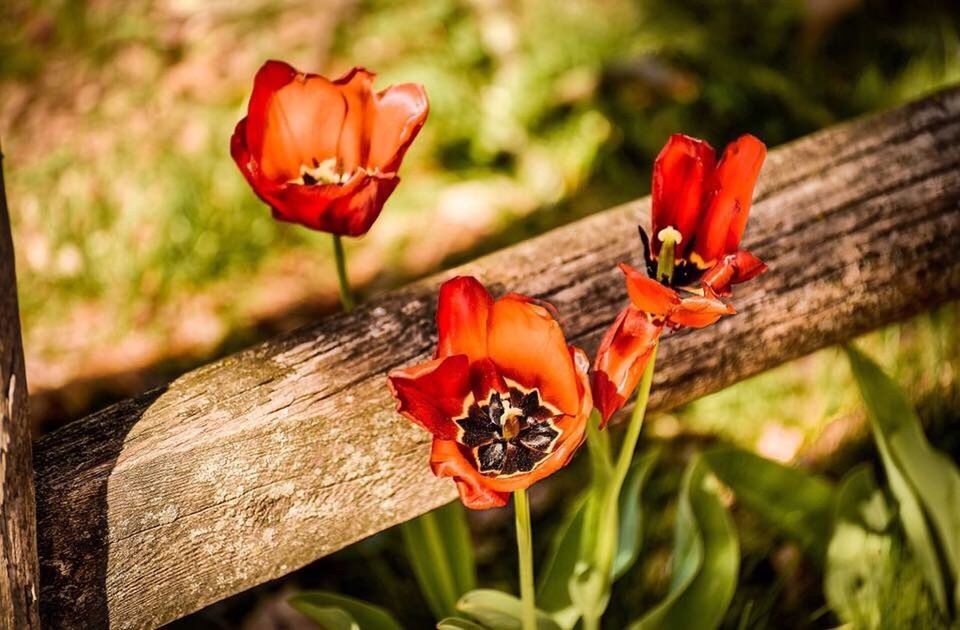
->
[[694, 135, 767, 263]]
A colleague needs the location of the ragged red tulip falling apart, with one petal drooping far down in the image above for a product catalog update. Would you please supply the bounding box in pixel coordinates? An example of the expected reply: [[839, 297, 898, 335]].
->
[[592, 134, 767, 423]]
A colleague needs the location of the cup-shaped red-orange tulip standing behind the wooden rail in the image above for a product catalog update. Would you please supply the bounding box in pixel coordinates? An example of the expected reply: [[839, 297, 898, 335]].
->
[[230, 61, 429, 236]]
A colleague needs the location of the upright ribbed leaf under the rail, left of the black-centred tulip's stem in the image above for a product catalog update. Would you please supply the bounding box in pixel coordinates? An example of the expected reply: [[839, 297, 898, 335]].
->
[[400, 501, 476, 619]]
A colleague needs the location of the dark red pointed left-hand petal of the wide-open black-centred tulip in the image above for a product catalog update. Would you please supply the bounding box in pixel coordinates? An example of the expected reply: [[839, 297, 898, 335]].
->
[[387, 354, 471, 440]]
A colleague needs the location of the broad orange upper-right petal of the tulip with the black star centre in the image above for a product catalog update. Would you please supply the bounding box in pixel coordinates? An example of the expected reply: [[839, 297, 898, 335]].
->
[[487, 294, 580, 415]]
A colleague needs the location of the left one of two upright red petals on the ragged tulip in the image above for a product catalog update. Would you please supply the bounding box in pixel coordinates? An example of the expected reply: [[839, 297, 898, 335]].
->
[[651, 134, 716, 258]]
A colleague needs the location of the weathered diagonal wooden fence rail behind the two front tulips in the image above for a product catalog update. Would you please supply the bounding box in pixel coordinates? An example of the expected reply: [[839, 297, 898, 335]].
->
[[36, 90, 960, 627]]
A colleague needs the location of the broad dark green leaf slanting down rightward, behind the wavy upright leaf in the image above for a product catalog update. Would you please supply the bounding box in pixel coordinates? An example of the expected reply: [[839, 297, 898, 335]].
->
[[703, 447, 834, 566]]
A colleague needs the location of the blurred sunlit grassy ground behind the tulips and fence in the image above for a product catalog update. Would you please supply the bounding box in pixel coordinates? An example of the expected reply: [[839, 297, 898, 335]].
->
[[0, 0, 960, 627]]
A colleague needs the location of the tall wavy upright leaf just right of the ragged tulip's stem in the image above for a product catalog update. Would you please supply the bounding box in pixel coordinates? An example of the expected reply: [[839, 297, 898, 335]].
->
[[630, 455, 740, 630]]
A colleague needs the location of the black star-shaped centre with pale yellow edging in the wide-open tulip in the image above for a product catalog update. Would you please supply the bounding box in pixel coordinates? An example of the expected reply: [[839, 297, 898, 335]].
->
[[454, 386, 561, 477]]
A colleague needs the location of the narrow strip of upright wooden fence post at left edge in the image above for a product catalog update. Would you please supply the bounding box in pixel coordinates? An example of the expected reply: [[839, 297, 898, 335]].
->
[[0, 147, 40, 630]]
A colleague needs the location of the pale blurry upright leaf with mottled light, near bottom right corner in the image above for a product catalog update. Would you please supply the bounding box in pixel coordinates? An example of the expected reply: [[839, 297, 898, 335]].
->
[[823, 465, 896, 628]]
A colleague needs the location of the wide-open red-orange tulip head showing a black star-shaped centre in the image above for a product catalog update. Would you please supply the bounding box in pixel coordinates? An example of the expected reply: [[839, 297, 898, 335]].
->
[[387, 277, 593, 509]]
